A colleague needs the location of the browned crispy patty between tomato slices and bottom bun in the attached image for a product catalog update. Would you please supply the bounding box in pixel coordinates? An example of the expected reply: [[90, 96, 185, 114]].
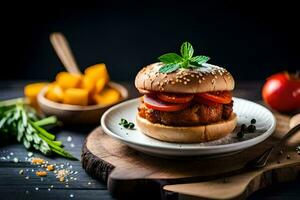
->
[[138, 101, 233, 126]]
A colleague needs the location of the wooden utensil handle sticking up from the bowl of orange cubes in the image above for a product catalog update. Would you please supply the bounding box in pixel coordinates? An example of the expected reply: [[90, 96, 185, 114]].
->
[[50, 32, 81, 74]]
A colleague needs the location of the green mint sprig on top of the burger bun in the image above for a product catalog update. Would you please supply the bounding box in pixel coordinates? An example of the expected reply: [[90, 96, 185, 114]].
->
[[158, 42, 210, 73]]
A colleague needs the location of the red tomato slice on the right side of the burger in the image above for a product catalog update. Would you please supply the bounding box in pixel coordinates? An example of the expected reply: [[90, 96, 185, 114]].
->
[[197, 91, 232, 104]]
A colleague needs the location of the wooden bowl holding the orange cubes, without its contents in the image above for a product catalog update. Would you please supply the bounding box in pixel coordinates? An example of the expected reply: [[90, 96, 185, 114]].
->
[[37, 82, 128, 124]]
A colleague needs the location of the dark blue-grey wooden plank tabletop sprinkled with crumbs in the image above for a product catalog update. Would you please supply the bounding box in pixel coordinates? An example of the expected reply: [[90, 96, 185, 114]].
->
[[0, 81, 300, 200]]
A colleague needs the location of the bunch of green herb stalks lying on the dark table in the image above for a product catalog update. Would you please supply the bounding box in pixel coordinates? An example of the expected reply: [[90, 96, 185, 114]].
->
[[0, 99, 77, 160]]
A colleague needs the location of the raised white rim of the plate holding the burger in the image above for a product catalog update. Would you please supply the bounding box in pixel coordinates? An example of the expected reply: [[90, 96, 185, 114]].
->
[[101, 97, 277, 151]]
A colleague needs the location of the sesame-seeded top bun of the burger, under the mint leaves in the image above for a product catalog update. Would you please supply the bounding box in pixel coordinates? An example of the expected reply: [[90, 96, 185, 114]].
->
[[135, 62, 234, 93]]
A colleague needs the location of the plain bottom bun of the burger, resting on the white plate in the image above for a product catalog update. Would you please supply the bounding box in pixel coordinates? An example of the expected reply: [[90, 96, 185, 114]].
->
[[136, 113, 237, 143]]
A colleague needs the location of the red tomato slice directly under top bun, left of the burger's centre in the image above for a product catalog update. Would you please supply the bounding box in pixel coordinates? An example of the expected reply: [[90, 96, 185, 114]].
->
[[157, 93, 194, 103]]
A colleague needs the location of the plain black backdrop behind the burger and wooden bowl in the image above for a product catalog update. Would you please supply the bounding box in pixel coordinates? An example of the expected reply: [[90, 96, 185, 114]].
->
[[0, 0, 299, 81]]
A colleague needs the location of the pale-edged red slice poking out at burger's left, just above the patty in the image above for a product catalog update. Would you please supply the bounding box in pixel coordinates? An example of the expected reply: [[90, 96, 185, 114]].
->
[[144, 95, 189, 112]]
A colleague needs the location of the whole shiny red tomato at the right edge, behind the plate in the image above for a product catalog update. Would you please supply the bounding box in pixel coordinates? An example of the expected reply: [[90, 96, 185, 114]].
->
[[262, 72, 300, 112]]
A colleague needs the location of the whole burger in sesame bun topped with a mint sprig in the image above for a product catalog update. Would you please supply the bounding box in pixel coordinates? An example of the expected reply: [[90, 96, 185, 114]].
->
[[135, 42, 237, 143]]
